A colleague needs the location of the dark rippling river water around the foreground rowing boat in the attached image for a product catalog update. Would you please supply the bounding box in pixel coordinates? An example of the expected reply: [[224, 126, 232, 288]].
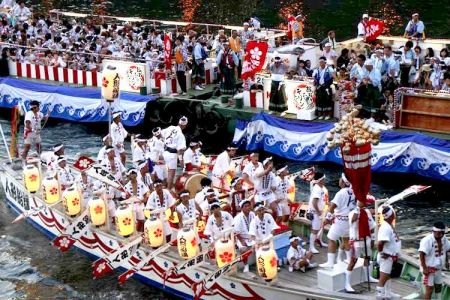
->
[[0, 119, 450, 299]]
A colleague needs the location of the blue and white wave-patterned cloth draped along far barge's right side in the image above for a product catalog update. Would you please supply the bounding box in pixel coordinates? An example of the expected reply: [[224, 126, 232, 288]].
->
[[233, 113, 450, 181]]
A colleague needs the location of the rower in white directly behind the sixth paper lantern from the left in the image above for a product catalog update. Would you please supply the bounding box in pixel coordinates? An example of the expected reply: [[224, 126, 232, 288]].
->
[[145, 179, 175, 242]]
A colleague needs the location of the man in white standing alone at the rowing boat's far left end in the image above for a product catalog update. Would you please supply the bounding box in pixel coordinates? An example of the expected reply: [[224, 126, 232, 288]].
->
[[21, 100, 49, 162]]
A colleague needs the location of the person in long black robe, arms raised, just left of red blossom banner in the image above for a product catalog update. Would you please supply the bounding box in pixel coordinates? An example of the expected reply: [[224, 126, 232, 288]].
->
[[216, 42, 239, 95]]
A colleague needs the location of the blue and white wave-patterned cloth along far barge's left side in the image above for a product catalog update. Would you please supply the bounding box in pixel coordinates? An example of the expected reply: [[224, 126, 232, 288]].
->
[[0, 78, 156, 126]]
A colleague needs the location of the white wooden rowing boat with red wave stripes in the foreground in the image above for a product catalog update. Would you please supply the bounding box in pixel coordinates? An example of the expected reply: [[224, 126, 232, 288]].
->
[[0, 158, 450, 299]]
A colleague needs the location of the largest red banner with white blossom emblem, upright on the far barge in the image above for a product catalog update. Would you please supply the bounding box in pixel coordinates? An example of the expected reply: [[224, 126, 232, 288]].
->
[[241, 41, 269, 80]]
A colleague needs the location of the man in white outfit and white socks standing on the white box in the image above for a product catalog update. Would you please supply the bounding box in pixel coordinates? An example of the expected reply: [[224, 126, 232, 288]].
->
[[320, 173, 356, 268]]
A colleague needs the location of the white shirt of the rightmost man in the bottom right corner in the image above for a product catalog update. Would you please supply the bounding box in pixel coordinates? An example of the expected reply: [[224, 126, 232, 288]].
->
[[419, 233, 450, 270]]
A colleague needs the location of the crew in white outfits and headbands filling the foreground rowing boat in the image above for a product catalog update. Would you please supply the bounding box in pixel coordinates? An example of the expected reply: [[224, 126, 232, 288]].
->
[[23, 101, 450, 299]]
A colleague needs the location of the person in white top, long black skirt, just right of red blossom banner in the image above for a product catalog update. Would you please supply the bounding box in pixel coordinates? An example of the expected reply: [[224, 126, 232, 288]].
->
[[267, 53, 289, 112]]
